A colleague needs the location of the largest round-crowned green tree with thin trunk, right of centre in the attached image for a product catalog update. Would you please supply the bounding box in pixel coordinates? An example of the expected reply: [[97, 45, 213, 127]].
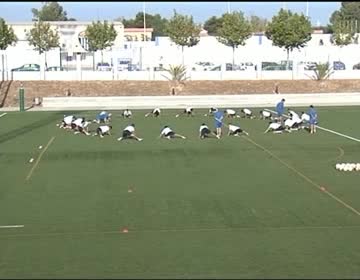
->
[[265, 9, 312, 68]]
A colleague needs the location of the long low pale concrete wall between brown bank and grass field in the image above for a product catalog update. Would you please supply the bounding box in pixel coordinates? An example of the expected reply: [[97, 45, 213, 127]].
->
[[42, 92, 360, 110]]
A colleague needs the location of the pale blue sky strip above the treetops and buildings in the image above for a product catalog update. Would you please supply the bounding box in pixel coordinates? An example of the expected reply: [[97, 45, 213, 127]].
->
[[0, 1, 341, 25]]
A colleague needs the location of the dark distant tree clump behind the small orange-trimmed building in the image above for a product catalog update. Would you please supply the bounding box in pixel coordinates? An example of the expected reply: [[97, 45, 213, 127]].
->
[[116, 12, 168, 40]]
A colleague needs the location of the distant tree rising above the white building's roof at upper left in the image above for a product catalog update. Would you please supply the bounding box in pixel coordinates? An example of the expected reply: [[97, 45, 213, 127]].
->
[[31, 2, 76, 21]]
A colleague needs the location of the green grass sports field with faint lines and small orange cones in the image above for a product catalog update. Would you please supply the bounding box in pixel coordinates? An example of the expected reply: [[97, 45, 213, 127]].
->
[[0, 107, 360, 279]]
